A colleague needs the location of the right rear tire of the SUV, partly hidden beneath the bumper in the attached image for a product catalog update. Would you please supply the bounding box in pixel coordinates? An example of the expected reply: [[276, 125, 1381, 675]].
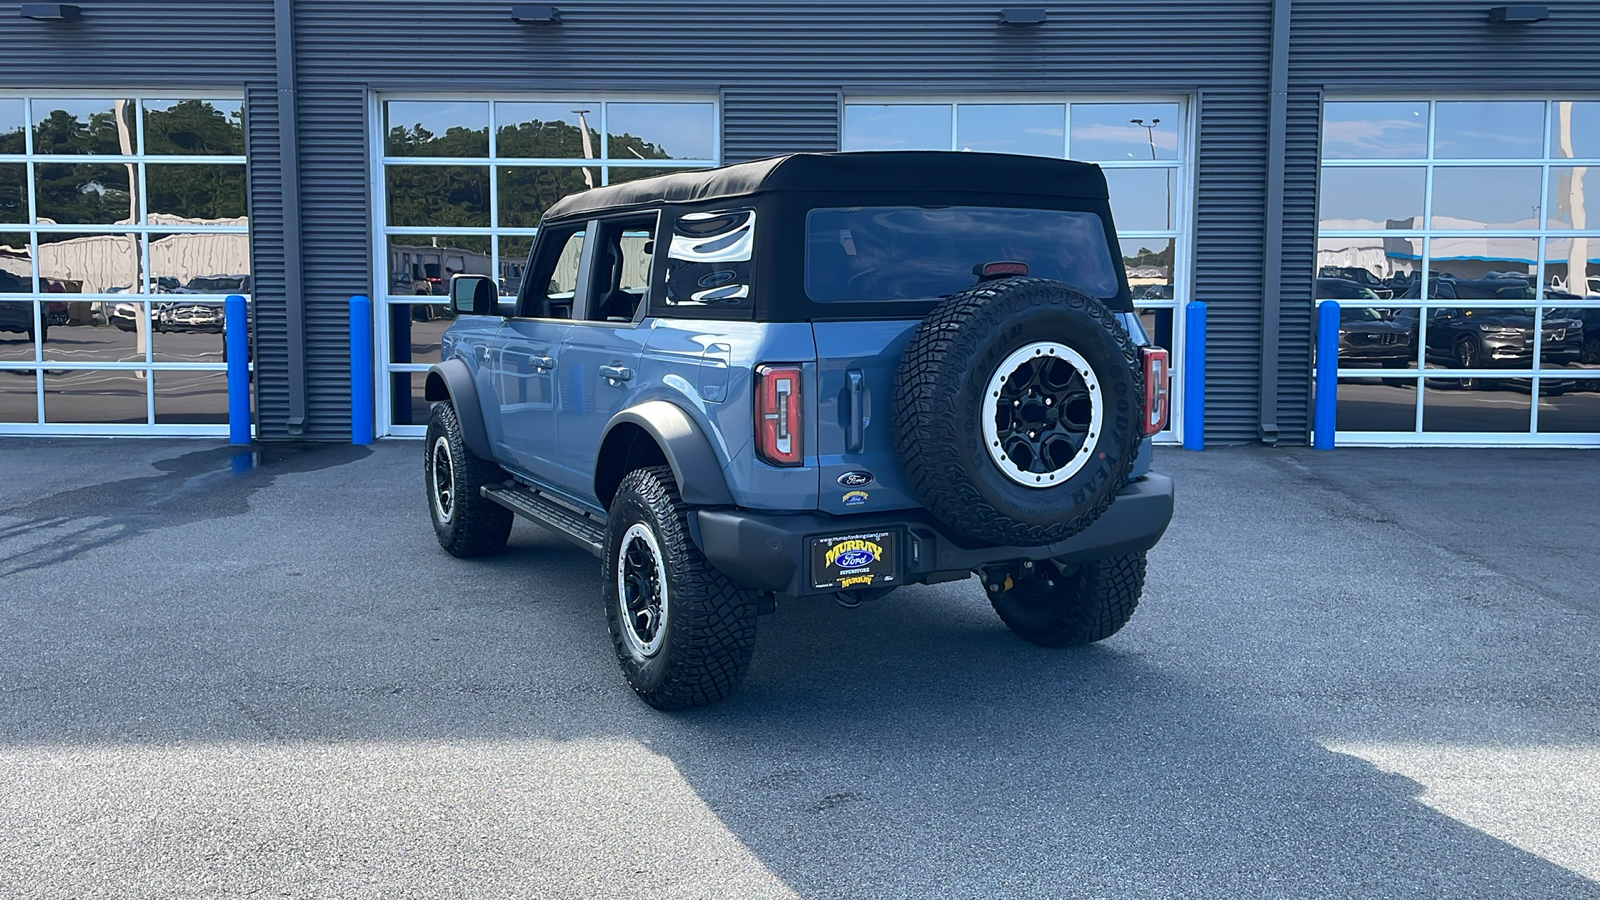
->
[[986, 551, 1144, 647]]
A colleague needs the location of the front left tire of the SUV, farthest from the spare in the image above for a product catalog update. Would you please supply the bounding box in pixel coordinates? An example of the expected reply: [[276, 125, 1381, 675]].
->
[[422, 402, 514, 559]]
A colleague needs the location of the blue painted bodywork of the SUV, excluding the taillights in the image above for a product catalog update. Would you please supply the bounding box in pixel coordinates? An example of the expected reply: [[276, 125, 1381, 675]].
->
[[442, 314, 1150, 516]]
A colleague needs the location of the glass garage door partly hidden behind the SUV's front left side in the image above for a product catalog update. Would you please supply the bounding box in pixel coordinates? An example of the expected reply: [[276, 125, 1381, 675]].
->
[[374, 94, 718, 434]]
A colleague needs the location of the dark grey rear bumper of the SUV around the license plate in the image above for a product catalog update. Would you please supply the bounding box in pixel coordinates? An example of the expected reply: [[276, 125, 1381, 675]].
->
[[691, 474, 1173, 596]]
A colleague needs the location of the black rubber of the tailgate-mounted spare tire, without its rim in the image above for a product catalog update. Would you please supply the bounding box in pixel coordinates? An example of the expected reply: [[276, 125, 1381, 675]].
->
[[893, 279, 1144, 546]]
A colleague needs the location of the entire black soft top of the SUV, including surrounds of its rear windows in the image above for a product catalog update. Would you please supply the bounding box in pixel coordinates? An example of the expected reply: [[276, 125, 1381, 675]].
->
[[546, 151, 1133, 322]]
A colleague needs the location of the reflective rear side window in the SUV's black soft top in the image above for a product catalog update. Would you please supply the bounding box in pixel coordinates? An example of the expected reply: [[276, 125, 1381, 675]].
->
[[667, 208, 755, 309]]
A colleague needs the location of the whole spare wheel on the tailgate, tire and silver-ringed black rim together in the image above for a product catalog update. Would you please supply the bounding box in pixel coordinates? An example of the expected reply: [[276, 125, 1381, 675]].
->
[[894, 277, 1144, 546]]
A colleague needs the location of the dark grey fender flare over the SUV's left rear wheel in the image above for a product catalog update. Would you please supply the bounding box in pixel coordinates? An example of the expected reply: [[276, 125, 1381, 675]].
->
[[595, 400, 734, 508]]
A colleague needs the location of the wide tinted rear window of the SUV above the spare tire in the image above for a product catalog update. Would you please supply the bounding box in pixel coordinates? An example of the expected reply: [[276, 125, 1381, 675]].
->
[[805, 207, 1118, 303]]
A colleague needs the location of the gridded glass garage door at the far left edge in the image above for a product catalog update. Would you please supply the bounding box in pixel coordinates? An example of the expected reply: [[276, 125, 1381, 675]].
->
[[0, 94, 251, 434]]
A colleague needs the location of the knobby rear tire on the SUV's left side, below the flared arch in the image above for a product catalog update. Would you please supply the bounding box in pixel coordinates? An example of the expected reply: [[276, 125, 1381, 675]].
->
[[602, 466, 757, 709]]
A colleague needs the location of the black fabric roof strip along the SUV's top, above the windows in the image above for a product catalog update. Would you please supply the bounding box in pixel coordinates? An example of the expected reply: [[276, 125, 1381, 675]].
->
[[546, 151, 1107, 219]]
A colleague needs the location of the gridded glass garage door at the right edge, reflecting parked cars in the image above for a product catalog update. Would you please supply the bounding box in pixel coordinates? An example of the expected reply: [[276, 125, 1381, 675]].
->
[[1317, 98, 1600, 445]]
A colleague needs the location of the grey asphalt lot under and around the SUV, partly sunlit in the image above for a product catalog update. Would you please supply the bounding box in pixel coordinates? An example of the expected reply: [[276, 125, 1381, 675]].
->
[[0, 439, 1600, 898]]
